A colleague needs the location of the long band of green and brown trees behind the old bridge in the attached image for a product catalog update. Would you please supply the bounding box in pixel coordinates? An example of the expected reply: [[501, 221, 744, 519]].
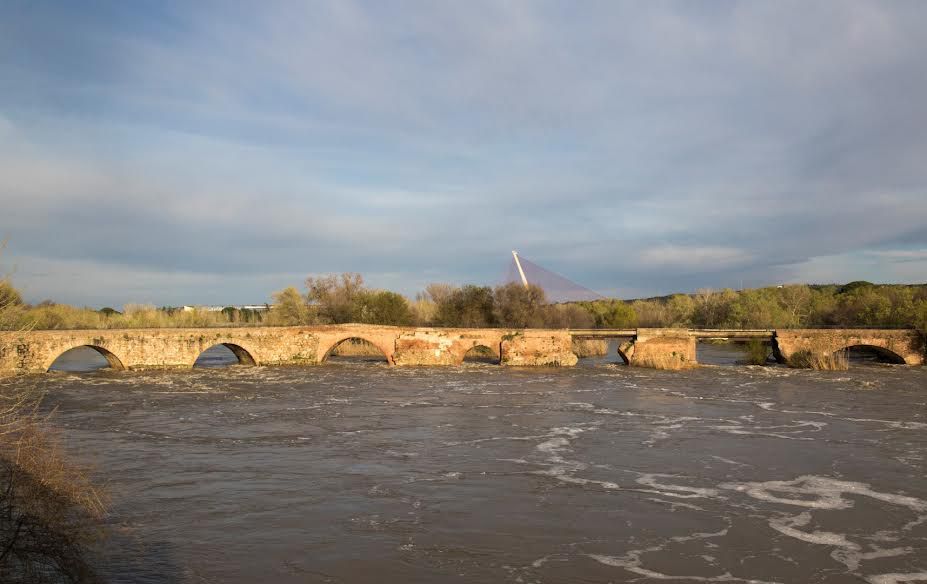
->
[[0, 273, 927, 331]]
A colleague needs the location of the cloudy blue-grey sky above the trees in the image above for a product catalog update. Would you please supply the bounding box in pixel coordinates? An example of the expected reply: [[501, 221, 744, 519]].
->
[[0, 0, 927, 307]]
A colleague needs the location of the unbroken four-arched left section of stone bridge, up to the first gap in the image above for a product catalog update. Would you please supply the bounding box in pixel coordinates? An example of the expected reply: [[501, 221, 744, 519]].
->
[[0, 324, 577, 376]]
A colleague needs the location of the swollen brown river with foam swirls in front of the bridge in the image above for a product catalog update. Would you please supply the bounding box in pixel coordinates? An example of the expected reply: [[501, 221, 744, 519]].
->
[[12, 346, 927, 584]]
